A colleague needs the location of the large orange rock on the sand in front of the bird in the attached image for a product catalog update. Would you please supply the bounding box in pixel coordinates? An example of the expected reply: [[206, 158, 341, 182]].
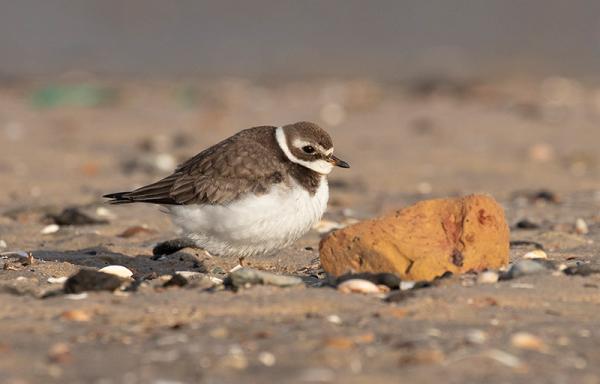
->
[[319, 195, 510, 280]]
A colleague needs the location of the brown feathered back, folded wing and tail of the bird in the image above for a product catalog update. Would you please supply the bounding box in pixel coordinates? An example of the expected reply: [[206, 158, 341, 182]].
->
[[105, 127, 284, 204]]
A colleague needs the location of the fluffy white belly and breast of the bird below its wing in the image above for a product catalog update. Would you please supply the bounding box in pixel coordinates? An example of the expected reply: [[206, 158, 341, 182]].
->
[[168, 177, 329, 257]]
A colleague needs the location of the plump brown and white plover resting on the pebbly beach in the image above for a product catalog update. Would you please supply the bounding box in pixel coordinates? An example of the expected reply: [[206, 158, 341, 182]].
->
[[103, 121, 350, 265]]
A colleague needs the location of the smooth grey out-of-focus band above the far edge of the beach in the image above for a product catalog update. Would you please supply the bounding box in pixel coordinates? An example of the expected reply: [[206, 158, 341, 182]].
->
[[0, 0, 600, 79]]
